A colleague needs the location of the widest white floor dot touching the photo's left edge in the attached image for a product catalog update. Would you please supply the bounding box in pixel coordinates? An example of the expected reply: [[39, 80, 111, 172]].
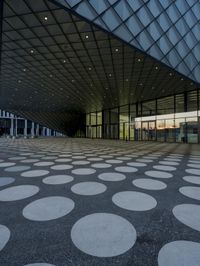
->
[[0, 185, 39, 201]]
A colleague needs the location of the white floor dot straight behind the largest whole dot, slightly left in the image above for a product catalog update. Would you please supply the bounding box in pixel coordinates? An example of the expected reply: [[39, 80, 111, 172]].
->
[[71, 182, 107, 196]]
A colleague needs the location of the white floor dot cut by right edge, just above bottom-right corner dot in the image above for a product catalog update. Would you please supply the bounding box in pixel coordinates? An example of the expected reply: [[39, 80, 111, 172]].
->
[[172, 204, 200, 231]]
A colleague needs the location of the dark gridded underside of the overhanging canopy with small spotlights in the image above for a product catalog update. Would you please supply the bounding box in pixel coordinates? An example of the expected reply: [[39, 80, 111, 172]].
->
[[0, 0, 198, 130]]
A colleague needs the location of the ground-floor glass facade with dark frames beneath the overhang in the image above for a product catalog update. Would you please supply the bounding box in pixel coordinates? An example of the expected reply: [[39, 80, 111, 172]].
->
[[86, 90, 200, 143]]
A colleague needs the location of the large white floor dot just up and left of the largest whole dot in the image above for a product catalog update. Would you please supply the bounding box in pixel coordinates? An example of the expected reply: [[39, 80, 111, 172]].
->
[[22, 196, 75, 221]]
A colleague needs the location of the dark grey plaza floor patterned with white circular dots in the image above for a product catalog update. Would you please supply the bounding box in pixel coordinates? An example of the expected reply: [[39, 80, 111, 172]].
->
[[0, 138, 200, 266]]
